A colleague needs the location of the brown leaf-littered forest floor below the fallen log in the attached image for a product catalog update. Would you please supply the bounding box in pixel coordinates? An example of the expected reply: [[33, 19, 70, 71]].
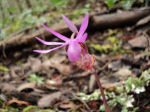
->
[[0, 0, 150, 112]]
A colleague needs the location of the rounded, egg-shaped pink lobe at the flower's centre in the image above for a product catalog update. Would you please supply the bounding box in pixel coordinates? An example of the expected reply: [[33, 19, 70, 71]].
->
[[67, 42, 81, 62]]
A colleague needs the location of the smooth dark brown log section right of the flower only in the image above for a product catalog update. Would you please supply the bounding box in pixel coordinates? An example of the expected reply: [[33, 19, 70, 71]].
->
[[91, 8, 150, 29]]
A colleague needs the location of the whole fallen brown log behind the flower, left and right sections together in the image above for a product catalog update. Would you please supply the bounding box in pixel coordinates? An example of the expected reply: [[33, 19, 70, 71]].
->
[[0, 8, 150, 57]]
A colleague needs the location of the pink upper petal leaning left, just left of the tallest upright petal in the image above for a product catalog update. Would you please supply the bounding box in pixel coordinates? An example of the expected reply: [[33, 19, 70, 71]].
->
[[61, 14, 78, 33]]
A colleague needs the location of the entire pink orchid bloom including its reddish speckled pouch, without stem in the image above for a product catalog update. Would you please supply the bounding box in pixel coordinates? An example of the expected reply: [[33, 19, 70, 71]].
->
[[34, 13, 94, 69]]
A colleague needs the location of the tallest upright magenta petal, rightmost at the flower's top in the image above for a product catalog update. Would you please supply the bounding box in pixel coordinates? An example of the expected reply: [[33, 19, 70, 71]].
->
[[77, 13, 89, 39]]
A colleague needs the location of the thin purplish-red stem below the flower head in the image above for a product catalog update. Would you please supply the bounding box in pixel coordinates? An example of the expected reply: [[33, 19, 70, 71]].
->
[[94, 68, 110, 112]]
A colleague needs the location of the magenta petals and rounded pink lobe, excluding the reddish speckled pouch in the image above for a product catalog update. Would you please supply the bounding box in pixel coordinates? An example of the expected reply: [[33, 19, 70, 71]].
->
[[34, 13, 88, 62]]
